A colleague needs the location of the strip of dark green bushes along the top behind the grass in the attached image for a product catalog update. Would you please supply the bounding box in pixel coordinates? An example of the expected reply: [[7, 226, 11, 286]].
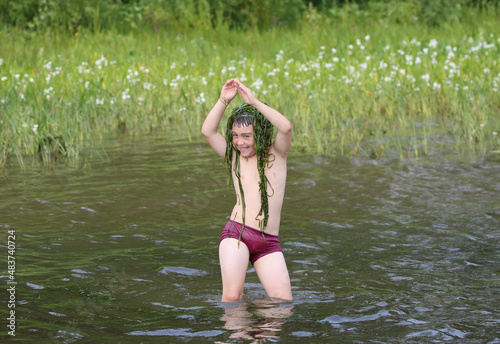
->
[[0, 0, 500, 34]]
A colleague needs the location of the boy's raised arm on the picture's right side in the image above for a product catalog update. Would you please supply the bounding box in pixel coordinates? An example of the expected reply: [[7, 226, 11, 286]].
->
[[237, 81, 292, 157]]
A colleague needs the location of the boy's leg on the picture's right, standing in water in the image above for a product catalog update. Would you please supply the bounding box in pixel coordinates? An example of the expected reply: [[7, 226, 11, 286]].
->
[[253, 252, 292, 300]]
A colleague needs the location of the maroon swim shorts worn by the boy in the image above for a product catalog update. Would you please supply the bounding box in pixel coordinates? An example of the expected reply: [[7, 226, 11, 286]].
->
[[219, 220, 283, 265]]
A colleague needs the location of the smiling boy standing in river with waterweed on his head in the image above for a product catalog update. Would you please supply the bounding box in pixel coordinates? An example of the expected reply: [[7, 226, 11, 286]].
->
[[201, 79, 292, 302]]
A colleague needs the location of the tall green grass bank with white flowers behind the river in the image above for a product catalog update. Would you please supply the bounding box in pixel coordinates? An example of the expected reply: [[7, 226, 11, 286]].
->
[[0, 0, 500, 171]]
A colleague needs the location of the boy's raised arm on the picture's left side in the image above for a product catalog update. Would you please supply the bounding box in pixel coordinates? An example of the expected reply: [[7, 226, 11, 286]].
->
[[201, 79, 238, 158]]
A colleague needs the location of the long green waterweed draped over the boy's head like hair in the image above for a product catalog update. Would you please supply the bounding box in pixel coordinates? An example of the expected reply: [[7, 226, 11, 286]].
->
[[225, 103, 274, 238]]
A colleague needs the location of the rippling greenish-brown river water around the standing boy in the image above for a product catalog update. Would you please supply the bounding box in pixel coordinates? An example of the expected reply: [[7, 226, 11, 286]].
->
[[0, 137, 500, 343]]
